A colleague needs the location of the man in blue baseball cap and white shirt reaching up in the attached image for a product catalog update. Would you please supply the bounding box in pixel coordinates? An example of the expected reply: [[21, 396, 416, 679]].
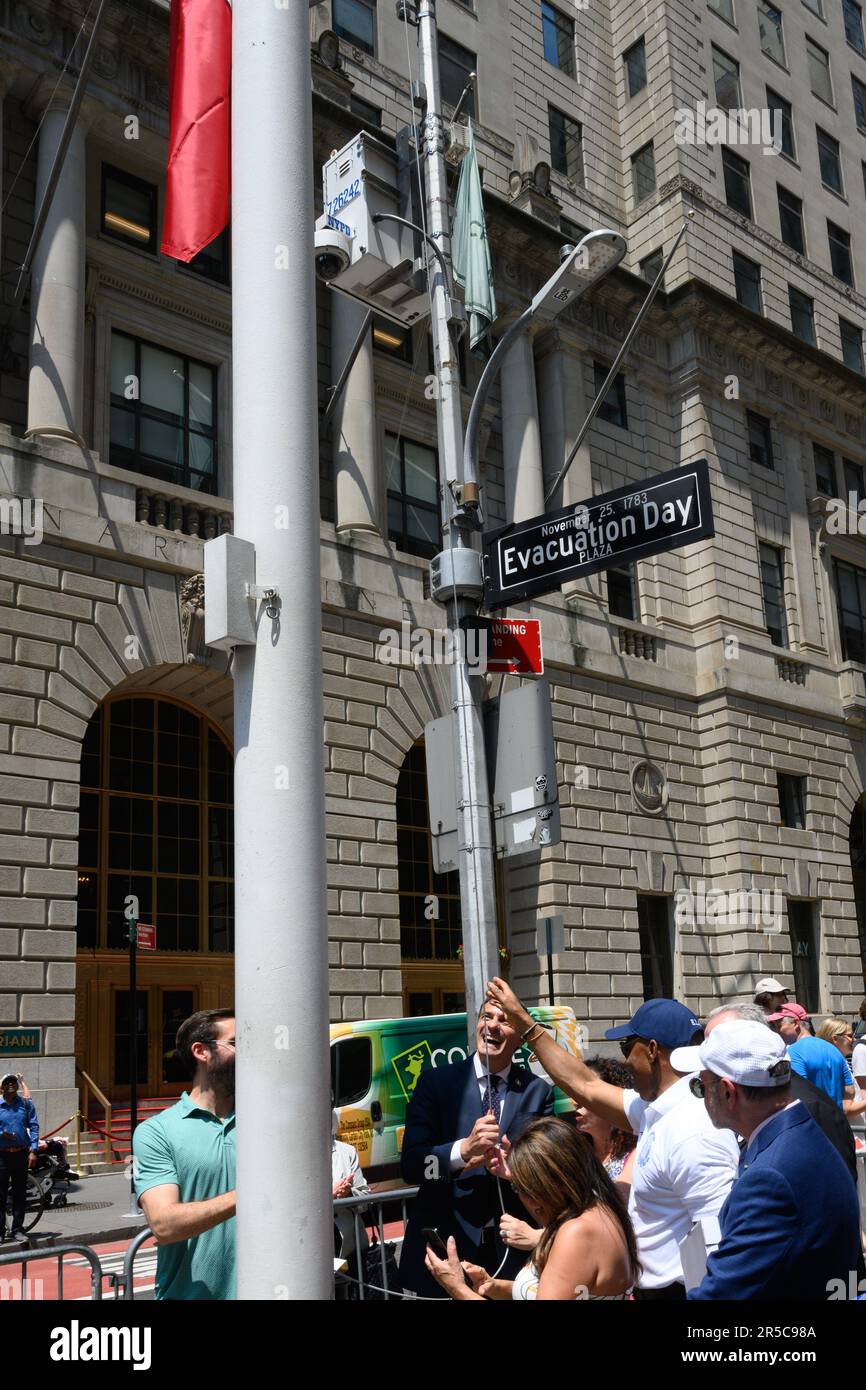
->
[[487, 979, 740, 1300]]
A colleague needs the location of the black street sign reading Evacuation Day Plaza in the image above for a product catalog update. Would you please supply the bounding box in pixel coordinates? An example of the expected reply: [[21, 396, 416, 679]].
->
[[484, 459, 714, 612]]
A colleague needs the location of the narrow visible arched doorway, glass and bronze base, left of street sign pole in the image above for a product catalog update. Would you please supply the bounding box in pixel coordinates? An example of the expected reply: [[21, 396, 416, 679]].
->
[[396, 742, 466, 1017]]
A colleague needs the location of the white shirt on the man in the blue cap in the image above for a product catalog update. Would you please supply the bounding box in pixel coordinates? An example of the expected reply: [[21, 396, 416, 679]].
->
[[623, 1076, 740, 1289]]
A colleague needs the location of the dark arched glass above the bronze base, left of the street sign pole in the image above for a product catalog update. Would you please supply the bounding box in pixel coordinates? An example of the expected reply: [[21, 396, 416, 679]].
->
[[396, 744, 463, 960]]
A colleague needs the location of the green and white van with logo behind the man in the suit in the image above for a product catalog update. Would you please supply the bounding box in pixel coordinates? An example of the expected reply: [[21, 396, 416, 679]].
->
[[331, 1005, 585, 1182]]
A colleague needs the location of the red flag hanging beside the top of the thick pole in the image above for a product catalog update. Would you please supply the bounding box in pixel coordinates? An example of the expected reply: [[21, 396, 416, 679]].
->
[[161, 0, 232, 261]]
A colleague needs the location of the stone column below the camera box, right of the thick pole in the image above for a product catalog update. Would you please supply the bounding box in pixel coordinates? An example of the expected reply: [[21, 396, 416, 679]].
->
[[331, 291, 381, 535]]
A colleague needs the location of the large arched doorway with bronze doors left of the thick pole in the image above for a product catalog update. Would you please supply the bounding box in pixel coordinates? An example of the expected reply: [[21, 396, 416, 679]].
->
[[75, 691, 234, 1099]]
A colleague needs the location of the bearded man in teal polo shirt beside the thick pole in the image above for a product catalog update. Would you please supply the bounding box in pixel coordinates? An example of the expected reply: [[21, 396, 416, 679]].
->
[[132, 1009, 235, 1300]]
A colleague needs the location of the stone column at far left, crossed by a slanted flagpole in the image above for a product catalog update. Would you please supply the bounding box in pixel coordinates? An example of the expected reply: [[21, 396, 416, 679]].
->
[[25, 99, 85, 443]]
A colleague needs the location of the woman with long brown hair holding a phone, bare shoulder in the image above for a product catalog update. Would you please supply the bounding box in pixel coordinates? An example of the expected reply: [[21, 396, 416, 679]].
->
[[427, 1118, 639, 1301]]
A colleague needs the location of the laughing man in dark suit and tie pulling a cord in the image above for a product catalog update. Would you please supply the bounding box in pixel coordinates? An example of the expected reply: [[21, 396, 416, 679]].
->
[[400, 1004, 553, 1298]]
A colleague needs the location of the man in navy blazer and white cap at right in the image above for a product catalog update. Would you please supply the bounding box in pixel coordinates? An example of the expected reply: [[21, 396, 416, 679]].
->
[[670, 1020, 860, 1301]]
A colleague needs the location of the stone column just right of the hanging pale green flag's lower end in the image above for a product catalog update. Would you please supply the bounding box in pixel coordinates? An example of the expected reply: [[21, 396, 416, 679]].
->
[[499, 334, 545, 521]]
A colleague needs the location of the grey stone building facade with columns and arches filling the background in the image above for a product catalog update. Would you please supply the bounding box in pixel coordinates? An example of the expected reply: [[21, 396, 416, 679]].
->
[[0, 0, 866, 1127]]
